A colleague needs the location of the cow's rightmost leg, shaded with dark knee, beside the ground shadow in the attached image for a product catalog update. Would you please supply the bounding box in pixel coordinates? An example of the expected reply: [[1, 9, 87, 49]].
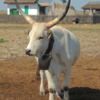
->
[[62, 67, 71, 100]]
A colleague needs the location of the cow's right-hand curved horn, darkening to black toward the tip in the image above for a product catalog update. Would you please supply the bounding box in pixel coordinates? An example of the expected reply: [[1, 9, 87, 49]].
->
[[45, 0, 71, 28]]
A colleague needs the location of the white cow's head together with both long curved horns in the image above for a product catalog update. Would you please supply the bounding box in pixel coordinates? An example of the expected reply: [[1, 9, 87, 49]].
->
[[15, 0, 70, 57]]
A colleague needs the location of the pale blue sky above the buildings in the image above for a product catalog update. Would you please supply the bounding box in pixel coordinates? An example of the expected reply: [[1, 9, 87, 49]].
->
[[0, 0, 100, 11]]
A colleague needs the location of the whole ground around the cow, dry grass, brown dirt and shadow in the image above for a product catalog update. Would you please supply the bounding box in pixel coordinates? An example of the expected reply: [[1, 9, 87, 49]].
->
[[0, 24, 100, 100]]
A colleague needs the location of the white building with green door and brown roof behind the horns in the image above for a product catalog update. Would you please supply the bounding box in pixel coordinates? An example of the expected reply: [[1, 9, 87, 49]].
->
[[4, 0, 66, 15]]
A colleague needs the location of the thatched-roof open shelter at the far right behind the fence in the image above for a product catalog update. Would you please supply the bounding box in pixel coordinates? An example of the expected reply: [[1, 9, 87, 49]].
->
[[82, 2, 100, 15]]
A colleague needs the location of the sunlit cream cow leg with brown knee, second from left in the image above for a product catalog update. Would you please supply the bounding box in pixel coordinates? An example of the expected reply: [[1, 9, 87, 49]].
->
[[45, 70, 55, 100]]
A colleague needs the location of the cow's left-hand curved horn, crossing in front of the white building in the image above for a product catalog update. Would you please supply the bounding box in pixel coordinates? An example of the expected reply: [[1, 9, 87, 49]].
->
[[15, 0, 35, 25]]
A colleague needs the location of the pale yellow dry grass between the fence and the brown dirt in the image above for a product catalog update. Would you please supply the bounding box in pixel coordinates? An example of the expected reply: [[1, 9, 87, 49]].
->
[[0, 24, 100, 58]]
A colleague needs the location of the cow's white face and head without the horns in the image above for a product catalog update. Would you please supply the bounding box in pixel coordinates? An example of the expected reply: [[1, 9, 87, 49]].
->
[[25, 23, 51, 57]]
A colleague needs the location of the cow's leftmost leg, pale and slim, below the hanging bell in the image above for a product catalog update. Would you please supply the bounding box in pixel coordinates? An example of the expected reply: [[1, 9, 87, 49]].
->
[[40, 70, 45, 95]]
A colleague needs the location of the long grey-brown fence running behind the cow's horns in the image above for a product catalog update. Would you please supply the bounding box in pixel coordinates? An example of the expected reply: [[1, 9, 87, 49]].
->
[[0, 14, 100, 24]]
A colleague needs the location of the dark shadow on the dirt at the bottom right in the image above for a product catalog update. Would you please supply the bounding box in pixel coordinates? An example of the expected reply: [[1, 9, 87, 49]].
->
[[69, 87, 100, 100]]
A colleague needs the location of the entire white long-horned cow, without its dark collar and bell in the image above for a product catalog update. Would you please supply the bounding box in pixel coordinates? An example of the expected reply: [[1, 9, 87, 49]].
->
[[15, 0, 80, 100]]
